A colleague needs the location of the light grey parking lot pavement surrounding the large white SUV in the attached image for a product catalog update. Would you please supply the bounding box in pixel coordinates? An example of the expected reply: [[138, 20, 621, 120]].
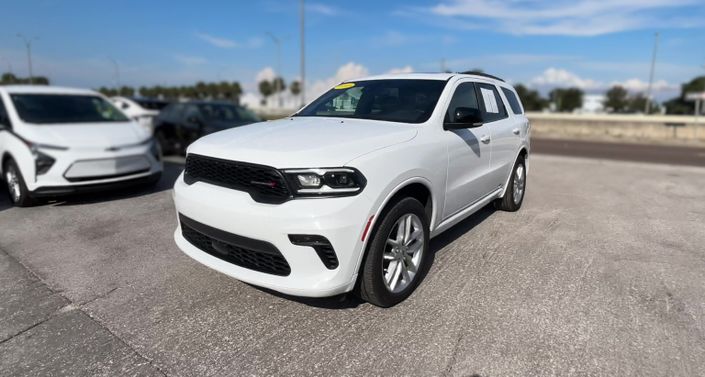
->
[[0, 151, 705, 376]]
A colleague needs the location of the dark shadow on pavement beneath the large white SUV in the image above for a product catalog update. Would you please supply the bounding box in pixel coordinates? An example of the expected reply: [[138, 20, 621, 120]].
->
[[248, 204, 497, 309]]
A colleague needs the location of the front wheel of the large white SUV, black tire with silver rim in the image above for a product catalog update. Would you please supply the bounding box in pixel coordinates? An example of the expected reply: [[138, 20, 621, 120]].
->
[[358, 198, 431, 308]]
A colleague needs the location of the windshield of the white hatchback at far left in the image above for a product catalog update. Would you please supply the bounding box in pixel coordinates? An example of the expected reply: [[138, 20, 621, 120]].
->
[[11, 94, 128, 124]]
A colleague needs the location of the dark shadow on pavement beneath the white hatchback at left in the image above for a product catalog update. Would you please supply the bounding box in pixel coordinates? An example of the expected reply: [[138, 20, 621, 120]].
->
[[49, 160, 184, 206]]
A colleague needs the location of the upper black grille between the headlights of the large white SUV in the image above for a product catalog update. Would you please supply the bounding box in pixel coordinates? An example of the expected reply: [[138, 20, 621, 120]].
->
[[184, 154, 291, 204]]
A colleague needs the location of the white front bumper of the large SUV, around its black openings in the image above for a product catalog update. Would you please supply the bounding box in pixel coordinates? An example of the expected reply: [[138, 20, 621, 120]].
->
[[174, 175, 373, 297]]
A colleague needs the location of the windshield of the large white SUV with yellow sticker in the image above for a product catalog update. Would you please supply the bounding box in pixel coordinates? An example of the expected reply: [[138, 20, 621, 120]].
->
[[296, 80, 446, 123]]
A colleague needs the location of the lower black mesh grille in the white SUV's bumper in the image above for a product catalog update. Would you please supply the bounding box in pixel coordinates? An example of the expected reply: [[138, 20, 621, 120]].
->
[[179, 214, 291, 276]]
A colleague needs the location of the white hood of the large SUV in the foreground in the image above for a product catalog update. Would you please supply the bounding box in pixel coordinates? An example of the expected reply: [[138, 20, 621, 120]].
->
[[188, 117, 417, 168]]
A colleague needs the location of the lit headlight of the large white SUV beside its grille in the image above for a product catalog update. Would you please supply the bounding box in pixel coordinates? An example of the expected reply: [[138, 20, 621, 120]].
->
[[284, 168, 367, 197]]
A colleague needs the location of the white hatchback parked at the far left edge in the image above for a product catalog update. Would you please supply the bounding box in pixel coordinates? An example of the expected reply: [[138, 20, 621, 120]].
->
[[0, 86, 162, 206]]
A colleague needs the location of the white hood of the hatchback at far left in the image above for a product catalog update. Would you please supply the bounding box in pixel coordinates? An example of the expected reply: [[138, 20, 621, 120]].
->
[[20, 122, 149, 149]]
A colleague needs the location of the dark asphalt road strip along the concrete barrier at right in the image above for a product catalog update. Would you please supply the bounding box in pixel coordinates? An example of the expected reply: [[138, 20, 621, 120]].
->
[[531, 138, 705, 166]]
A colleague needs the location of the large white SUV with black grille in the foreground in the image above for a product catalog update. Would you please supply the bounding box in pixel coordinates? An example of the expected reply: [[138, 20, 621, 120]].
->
[[174, 74, 529, 307]]
